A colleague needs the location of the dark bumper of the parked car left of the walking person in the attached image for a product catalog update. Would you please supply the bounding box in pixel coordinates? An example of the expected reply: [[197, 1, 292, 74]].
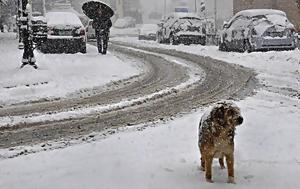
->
[[42, 36, 86, 53]]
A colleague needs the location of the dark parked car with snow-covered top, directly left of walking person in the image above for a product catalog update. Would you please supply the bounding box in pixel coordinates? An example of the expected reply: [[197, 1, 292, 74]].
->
[[41, 12, 87, 53]]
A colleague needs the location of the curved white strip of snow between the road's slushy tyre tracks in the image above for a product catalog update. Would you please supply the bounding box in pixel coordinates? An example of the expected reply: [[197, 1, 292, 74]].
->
[[0, 49, 205, 127]]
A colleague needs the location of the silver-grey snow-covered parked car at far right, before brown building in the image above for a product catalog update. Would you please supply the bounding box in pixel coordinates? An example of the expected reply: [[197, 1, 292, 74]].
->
[[219, 9, 297, 52]]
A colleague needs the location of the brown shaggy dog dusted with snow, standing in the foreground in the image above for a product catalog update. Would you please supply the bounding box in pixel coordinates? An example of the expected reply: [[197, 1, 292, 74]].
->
[[198, 101, 244, 183]]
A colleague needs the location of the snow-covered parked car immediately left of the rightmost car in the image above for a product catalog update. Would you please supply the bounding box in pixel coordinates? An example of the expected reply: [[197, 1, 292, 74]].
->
[[157, 13, 206, 45]]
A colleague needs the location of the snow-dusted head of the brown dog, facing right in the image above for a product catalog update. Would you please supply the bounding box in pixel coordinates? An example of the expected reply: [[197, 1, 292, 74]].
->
[[212, 101, 244, 127]]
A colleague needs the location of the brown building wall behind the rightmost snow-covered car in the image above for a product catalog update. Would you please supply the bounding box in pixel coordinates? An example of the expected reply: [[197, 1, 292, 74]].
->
[[233, 0, 300, 31]]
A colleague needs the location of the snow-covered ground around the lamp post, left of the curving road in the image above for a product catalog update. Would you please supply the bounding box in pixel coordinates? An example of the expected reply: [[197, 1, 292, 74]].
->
[[0, 33, 142, 105]]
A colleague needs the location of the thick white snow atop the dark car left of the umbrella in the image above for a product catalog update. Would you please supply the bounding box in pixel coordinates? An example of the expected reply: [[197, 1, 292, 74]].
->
[[46, 12, 83, 27]]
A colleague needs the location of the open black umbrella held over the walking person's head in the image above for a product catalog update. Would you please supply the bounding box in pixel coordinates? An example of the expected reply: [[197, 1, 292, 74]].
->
[[82, 0, 115, 19]]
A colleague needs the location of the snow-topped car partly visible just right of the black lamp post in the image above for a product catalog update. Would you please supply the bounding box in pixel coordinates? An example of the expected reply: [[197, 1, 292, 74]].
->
[[31, 12, 48, 46]]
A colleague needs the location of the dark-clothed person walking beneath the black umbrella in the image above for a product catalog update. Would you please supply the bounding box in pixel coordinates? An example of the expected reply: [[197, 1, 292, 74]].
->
[[93, 9, 112, 55]]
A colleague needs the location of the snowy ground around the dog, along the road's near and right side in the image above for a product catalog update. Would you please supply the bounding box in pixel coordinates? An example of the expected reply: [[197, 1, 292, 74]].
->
[[0, 35, 300, 189]]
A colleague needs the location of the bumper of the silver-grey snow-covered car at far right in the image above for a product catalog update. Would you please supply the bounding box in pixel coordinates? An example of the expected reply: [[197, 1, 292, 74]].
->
[[251, 37, 297, 50]]
